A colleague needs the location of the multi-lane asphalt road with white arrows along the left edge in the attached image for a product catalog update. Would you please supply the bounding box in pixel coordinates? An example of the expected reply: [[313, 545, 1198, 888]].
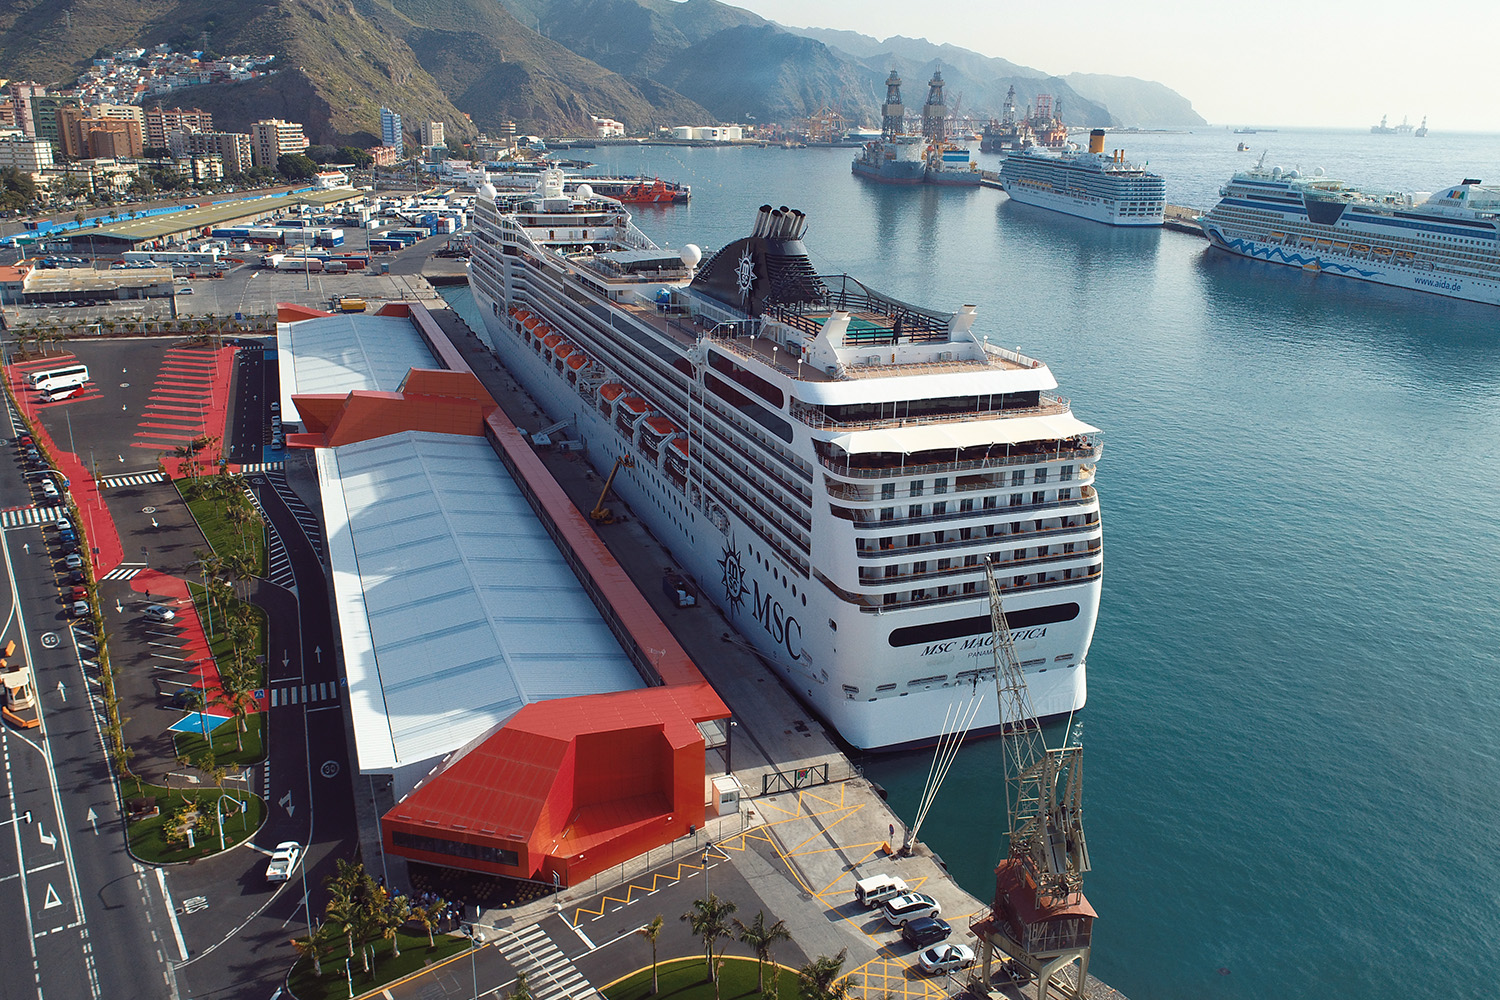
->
[[0, 401, 176, 997]]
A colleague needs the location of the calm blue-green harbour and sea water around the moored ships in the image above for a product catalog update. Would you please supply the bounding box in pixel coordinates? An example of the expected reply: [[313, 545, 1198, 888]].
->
[[441, 129, 1500, 1000]]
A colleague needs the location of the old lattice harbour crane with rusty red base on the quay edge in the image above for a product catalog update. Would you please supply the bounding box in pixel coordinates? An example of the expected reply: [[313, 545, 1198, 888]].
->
[[972, 565, 1095, 1000]]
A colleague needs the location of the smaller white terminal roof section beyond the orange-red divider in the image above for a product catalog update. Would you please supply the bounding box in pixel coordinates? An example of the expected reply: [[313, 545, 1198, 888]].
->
[[276, 313, 440, 420]]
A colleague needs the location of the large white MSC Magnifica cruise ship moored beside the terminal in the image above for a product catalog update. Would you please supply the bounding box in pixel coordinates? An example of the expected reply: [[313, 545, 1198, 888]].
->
[[470, 171, 1103, 750]]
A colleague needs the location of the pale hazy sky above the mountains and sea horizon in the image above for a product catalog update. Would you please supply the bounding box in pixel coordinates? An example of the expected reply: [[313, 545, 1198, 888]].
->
[[728, 0, 1500, 132]]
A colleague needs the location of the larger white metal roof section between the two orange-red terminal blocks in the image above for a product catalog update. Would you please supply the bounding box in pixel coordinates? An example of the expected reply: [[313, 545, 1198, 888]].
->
[[318, 432, 644, 771]]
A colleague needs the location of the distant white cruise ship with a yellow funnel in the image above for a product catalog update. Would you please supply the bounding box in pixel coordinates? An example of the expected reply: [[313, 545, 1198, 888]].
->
[[1001, 129, 1167, 226]]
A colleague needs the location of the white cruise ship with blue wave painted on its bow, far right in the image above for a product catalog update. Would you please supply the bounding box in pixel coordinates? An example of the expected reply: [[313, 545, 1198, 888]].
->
[[1202, 163, 1500, 306]]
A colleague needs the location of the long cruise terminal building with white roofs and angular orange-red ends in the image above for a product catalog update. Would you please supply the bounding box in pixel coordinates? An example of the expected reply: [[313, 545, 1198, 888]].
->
[[276, 303, 729, 885]]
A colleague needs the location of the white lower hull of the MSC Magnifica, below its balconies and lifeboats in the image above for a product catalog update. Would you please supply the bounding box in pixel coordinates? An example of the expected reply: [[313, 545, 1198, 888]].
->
[[471, 285, 1101, 751]]
